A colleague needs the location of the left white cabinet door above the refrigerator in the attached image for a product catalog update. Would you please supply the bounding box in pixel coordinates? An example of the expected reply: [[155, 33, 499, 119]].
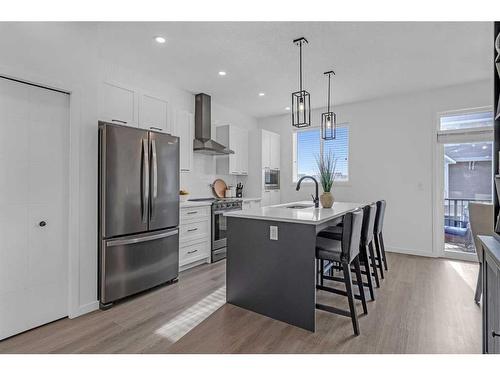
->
[[99, 82, 137, 126]]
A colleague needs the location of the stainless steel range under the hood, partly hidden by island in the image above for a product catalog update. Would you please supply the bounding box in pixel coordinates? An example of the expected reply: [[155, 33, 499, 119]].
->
[[190, 198, 243, 263]]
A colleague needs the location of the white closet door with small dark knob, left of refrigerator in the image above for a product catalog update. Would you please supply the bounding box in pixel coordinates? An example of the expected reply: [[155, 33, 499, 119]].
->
[[0, 78, 69, 340]]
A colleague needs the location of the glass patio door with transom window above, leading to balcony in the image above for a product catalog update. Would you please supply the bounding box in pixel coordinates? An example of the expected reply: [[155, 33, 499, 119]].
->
[[434, 109, 493, 260]]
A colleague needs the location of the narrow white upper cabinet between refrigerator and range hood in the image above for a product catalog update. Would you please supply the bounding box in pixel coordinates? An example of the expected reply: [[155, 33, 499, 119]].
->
[[172, 109, 194, 172]]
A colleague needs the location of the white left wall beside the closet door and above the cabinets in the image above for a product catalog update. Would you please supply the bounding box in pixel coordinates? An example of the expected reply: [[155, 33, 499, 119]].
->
[[0, 23, 260, 316]]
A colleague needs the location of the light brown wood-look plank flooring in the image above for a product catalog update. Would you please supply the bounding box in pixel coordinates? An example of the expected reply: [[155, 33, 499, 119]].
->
[[0, 253, 481, 353]]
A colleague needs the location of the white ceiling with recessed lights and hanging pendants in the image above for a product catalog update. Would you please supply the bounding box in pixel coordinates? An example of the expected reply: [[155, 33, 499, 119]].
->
[[4, 22, 493, 117]]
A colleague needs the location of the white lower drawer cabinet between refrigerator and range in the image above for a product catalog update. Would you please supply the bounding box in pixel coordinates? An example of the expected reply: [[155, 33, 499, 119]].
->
[[179, 206, 211, 271]]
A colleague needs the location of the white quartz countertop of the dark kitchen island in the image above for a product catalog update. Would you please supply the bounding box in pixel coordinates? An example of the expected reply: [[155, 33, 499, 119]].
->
[[224, 201, 364, 225]]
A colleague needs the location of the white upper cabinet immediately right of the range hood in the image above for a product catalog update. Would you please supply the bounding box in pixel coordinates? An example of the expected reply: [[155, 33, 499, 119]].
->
[[216, 125, 248, 176]]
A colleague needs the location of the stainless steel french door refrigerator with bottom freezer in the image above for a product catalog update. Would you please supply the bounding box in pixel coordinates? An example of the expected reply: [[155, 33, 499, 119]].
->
[[98, 121, 179, 309]]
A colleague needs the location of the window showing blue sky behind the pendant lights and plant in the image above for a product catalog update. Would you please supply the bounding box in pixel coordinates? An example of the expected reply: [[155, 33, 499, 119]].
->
[[293, 125, 349, 182]]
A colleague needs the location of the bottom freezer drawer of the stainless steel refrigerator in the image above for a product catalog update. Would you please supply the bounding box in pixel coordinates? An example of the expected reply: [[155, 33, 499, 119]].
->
[[99, 228, 179, 305]]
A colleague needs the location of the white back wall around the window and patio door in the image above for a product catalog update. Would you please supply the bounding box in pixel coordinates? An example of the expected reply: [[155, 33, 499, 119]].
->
[[259, 81, 493, 256]]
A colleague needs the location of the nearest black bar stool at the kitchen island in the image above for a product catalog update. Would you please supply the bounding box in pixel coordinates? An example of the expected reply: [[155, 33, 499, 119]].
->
[[316, 210, 368, 335]]
